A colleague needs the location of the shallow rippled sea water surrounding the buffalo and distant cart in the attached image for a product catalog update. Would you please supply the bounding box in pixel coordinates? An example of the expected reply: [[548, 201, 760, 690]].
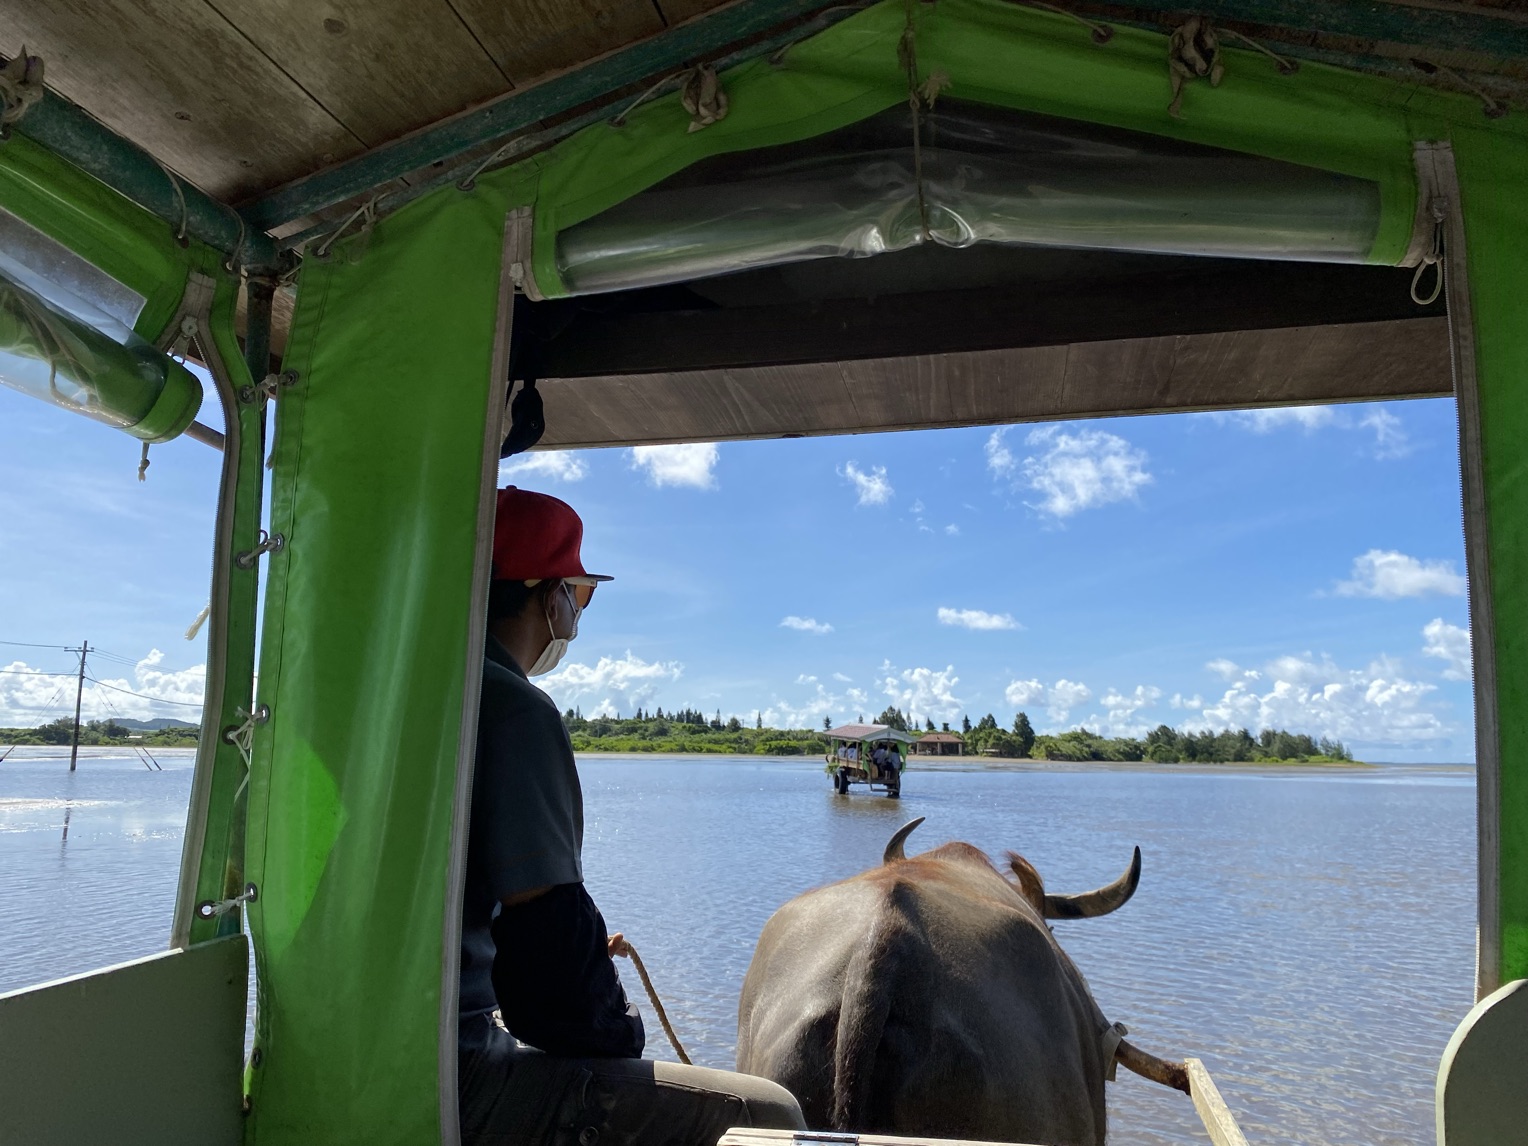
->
[[0, 752, 1475, 1146]]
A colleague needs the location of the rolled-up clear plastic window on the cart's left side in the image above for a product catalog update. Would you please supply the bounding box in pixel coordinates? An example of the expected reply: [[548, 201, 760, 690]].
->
[[0, 275, 202, 442]]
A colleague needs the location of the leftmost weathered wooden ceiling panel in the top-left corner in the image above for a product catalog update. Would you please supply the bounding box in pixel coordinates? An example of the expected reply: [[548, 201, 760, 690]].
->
[[0, 0, 362, 202]]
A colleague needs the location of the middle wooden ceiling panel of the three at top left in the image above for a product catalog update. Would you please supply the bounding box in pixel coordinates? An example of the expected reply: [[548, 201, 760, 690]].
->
[[208, 0, 510, 148]]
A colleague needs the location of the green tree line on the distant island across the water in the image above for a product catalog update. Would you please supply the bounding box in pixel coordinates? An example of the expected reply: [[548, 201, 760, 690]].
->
[[562, 706, 1352, 764]]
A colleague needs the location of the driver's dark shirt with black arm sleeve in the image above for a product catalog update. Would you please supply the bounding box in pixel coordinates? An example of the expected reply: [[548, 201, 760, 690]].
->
[[460, 636, 645, 1059]]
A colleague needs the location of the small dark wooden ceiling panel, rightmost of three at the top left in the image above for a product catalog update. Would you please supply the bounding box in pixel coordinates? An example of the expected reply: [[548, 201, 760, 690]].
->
[[451, 0, 665, 86]]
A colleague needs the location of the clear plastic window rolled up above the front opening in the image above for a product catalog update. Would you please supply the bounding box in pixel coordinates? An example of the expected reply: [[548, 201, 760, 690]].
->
[[556, 101, 1380, 293]]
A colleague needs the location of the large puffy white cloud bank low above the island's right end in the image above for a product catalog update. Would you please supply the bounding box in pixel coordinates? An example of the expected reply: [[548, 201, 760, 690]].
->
[[1186, 654, 1452, 749]]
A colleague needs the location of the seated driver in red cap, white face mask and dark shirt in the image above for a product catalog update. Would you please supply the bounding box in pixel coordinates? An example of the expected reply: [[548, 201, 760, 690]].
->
[[457, 486, 805, 1146]]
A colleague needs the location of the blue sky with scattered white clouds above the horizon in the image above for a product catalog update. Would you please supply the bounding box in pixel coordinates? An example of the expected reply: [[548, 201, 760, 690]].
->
[[0, 390, 1473, 761]]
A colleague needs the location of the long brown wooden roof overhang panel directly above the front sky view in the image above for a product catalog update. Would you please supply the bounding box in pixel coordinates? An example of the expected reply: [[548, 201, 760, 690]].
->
[[538, 318, 1452, 449]]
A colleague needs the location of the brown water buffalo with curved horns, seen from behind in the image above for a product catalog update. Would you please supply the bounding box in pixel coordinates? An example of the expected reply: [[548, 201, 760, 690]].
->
[[738, 817, 1187, 1146]]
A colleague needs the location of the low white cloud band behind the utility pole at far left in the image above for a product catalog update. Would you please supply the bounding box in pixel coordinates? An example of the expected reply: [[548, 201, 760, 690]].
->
[[0, 649, 206, 727]]
